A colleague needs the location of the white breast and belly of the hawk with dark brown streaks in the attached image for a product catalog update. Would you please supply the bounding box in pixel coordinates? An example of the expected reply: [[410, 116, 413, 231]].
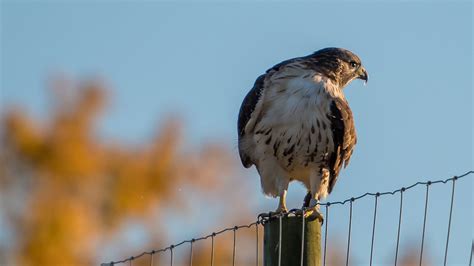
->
[[254, 73, 334, 173]]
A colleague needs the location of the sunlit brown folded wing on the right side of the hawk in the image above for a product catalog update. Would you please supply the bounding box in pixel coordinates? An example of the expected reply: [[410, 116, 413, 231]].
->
[[328, 98, 357, 193]]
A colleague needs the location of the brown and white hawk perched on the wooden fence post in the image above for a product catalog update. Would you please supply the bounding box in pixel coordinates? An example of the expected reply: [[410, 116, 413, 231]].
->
[[238, 48, 368, 219]]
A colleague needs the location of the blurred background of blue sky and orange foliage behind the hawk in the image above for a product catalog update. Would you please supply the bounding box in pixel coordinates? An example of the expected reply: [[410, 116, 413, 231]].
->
[[0, 1, 474, 265]]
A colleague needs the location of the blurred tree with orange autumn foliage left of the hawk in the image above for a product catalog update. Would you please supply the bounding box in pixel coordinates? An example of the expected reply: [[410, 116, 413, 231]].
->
[[0, 80, 254, 265]]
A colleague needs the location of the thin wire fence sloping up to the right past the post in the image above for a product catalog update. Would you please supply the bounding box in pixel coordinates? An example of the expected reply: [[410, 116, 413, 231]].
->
[[101, 171, 474, 266]]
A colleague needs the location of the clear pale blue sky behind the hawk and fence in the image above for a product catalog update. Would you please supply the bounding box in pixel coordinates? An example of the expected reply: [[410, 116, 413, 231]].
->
[[0, 1, 474, 265]]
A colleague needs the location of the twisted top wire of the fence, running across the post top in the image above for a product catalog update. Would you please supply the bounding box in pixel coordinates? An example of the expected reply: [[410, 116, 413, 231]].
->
[[101, 170, 474, 266]]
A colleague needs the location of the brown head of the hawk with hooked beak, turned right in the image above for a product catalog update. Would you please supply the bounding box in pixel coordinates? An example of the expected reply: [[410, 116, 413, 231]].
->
[[308, 47, 369, 88]]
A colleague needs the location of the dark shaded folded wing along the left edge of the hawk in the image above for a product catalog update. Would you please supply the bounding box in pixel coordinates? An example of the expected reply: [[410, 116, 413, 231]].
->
[[237, 57, 304, 168]]
